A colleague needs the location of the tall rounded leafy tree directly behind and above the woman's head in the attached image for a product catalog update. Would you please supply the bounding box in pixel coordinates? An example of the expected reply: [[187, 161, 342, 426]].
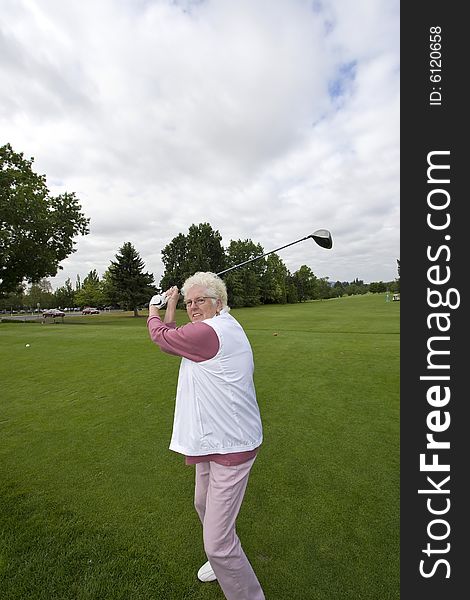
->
[[160, 223, 225, 290]]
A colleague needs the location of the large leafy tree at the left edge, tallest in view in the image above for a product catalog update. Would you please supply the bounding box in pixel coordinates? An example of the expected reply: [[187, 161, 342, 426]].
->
[[0, 144, 89, 295]]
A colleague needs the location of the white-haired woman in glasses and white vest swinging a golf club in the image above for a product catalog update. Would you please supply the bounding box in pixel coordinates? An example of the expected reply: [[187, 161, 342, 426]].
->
[[147, 272, 264, 600]]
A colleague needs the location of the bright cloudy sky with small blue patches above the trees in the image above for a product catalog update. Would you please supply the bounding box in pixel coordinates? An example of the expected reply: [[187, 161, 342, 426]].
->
[[0, 0, 400, 288]]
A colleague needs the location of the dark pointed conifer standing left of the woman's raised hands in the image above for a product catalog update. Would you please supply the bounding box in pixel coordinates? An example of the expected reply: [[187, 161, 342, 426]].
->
[[108, 242, 156, 317]]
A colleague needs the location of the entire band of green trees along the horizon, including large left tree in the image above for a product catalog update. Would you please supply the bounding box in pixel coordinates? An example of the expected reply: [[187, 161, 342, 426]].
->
[[0, 144, 399, 315]]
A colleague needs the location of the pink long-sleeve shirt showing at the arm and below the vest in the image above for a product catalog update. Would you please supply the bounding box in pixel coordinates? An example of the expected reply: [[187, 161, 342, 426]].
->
[[147, 316, 258, 466]]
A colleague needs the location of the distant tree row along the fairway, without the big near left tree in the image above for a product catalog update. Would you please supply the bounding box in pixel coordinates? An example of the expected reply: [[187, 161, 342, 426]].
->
[[0, 223, 399, 316]]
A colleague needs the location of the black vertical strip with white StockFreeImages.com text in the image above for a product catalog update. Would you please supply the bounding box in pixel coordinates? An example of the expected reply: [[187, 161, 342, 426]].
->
[[400, 0, 469, 600]]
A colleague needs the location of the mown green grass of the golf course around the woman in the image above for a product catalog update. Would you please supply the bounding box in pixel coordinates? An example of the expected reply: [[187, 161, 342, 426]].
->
[[0, 295, 399, 600]]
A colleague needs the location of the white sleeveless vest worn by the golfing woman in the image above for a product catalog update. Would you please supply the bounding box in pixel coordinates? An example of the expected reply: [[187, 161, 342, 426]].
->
[[170, 311, 263, 456]]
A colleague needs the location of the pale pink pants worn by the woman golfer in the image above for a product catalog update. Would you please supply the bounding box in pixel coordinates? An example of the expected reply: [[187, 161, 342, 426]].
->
[[194, 458, 265, 600]]
